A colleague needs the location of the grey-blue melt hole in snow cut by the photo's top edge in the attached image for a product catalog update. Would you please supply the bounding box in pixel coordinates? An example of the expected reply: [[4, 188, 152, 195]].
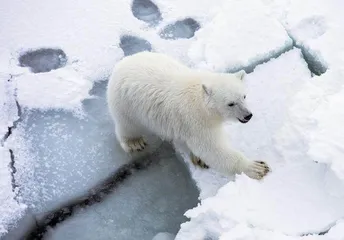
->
[[131, 0, 162, 25]]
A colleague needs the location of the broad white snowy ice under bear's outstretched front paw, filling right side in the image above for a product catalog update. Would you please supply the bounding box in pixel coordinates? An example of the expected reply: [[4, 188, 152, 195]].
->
[[176, 0, 344, 240]]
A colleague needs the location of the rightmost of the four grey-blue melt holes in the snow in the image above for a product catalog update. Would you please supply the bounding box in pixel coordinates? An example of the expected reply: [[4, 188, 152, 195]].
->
[[160, 18, 201, 39]]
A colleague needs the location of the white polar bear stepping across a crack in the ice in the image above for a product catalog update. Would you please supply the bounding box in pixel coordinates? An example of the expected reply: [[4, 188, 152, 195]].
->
[[107, 52, 269, 179]]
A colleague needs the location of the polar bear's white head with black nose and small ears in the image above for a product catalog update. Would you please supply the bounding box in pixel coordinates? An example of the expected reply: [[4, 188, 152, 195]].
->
[[202, 70, 252, 123]]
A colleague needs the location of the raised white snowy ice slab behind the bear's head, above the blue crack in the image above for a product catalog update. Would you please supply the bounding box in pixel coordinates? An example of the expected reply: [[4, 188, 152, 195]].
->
[[189, 0, 293, 72]]
